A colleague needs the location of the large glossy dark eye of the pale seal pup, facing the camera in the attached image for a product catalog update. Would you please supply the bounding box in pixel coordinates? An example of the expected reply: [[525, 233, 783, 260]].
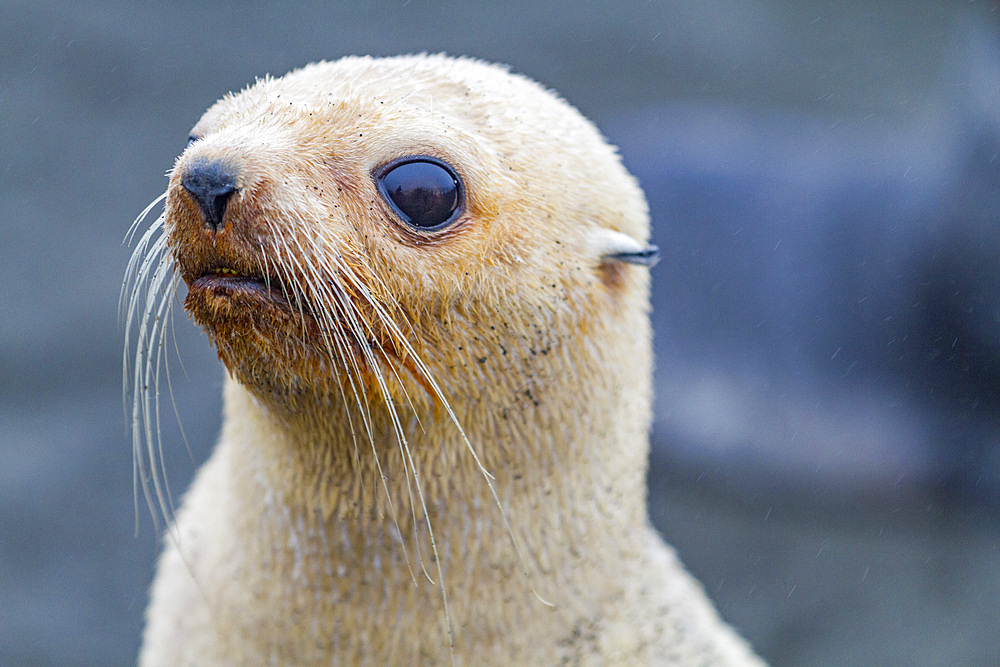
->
[[375, 157, 462, 230]]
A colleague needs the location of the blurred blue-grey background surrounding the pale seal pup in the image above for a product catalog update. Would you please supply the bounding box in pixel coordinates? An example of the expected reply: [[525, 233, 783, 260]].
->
[[0, 0, 1000, 665]]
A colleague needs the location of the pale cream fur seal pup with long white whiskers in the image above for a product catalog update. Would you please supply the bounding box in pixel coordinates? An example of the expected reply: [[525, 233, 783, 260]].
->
[[123, 55, 757, 665]]
